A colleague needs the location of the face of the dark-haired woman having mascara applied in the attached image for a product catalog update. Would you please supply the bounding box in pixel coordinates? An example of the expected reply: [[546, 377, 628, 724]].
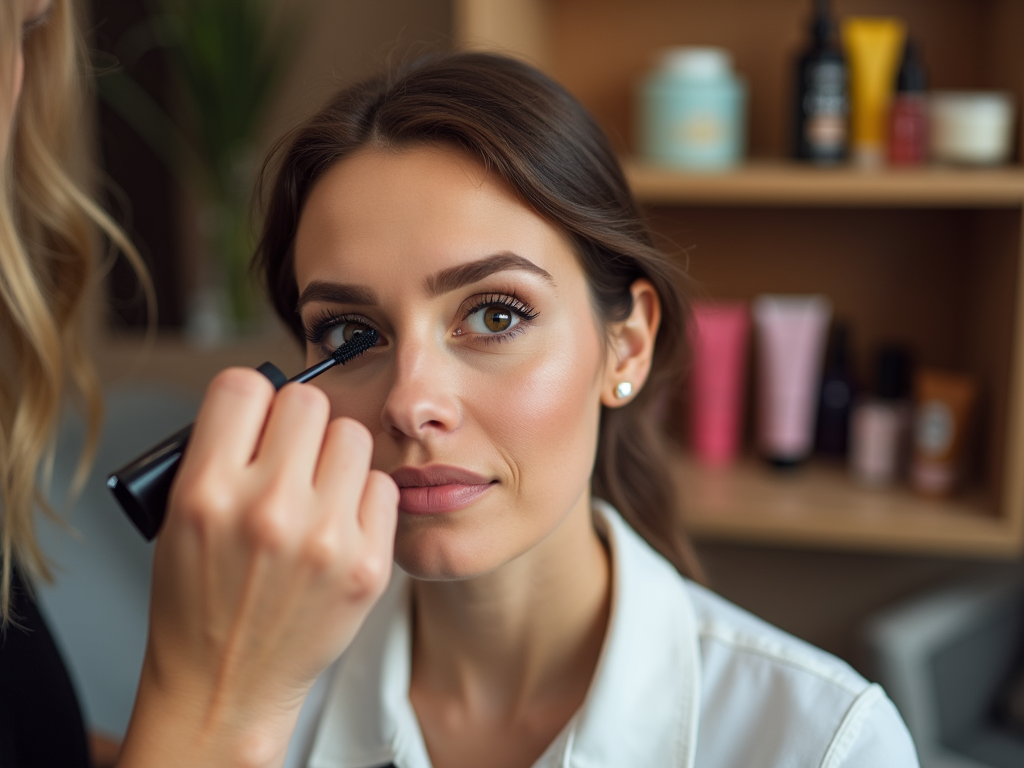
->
[[295, 146, 607, 579]]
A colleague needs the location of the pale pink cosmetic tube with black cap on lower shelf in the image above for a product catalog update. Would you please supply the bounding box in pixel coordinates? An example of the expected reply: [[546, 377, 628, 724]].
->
[[753, 294, 831, 467]]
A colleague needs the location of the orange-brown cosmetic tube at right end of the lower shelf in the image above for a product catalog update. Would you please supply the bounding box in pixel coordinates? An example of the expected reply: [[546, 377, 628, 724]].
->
[[910, 370, 978, 497]]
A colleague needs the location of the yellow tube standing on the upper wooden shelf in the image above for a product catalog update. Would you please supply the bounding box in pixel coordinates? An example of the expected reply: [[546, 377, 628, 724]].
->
[[843, 16, 906, 166]]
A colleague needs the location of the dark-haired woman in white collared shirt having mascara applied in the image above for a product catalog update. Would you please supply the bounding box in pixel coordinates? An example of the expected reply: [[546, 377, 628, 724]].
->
[[257, 53, 916, 768]]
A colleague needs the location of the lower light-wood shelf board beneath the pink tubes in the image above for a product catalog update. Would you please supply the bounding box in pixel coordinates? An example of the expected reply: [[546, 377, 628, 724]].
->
[[676, 457, 1024, 557]]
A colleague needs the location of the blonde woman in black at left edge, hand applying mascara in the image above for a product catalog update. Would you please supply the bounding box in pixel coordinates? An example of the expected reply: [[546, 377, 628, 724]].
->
[[0, 0, 397, 768]]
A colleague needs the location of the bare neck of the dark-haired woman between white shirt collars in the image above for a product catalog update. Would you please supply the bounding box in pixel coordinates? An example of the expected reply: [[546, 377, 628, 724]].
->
[[413, 495, 611, 718]]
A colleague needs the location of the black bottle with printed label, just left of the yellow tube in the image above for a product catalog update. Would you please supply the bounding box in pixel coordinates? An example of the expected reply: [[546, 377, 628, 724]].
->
[[793, 0, 850, 164]]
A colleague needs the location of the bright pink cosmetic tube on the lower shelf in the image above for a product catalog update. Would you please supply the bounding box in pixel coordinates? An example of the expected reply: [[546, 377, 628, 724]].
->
[[690, 301, 751, 466]]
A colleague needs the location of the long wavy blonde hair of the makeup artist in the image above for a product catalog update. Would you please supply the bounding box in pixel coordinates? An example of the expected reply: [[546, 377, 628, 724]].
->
[[0, 0, 155, 624]]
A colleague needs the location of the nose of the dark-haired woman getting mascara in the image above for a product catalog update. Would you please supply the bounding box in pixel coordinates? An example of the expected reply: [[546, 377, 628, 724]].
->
[[381, 339, 461, 440]]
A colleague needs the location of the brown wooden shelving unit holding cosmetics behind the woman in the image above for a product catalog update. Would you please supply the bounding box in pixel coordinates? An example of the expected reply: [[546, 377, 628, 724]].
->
[[454, 0, 1024, 557]]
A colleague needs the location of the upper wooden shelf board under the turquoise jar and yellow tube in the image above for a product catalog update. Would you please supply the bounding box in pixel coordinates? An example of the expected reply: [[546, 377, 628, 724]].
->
[[624, 159, 1024, 208]]
